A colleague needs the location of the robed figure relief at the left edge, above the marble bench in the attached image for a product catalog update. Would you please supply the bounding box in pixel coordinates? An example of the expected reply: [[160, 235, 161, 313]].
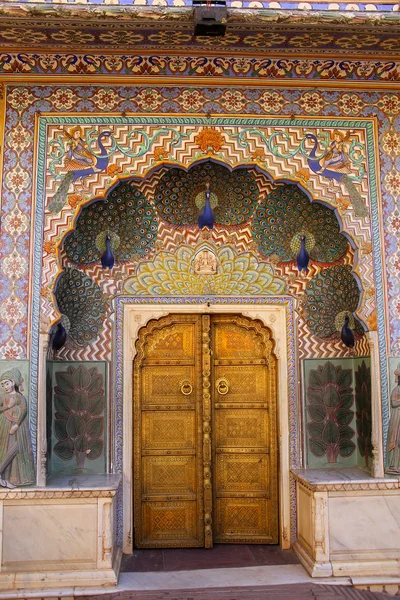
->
[[0, 368, 35, 488]]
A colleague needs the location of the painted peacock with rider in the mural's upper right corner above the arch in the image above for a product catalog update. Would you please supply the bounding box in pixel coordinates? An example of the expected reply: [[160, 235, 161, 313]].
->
[[306, 131, 369, 217]]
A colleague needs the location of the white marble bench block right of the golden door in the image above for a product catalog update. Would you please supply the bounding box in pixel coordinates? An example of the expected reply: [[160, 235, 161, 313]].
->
[[292, 467, 400, 578]]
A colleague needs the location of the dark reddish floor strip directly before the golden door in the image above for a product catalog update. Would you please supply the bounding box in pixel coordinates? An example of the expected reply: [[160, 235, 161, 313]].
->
[[121, 544, 299, 573]]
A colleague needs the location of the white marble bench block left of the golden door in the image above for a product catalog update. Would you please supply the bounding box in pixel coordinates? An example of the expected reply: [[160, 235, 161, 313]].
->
[[0, 475, 121, 590]]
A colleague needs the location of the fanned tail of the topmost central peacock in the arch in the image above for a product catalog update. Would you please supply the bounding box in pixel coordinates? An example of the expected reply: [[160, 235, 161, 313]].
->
[[154, 162, 259, 226]]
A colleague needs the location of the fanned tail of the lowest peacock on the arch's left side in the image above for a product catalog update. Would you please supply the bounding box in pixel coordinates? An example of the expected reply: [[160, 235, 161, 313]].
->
[[55, 268, 106, 346]]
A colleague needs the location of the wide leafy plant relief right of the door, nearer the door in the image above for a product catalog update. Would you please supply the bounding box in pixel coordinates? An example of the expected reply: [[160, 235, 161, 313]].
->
[[307, 361, 356, 463]]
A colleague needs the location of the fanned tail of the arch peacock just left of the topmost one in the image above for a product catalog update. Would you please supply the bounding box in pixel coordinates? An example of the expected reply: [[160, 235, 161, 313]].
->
[[64, 182, 158, 265]]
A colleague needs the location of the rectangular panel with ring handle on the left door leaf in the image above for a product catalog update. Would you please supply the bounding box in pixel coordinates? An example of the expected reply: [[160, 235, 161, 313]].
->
[[142, 365, 195, 406]]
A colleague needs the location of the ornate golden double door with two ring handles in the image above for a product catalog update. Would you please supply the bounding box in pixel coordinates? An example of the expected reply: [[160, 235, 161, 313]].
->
[[134, 315, 278, 548]]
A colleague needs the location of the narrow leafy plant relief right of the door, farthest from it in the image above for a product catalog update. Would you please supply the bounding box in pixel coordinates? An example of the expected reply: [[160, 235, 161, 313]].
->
[[355, 360, 373, 467]]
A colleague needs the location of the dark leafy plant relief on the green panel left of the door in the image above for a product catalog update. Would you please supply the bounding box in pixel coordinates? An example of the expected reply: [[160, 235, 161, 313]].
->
[[54, 365, 105, 470]]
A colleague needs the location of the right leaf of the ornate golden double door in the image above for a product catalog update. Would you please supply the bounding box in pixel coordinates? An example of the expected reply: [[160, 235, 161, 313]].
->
[[211, 315, 278, 544]]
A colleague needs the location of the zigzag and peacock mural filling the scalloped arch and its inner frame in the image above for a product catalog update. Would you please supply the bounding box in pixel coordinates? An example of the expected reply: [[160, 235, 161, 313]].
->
[[36, 118, 375, 370]]
